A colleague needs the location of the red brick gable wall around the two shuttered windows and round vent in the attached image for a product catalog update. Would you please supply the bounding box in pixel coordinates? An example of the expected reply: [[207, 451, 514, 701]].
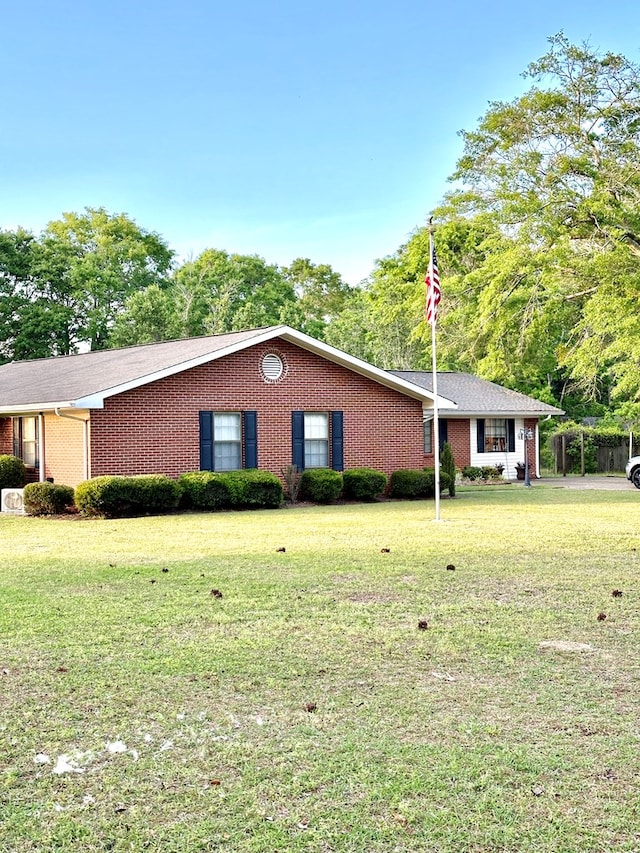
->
[[91, 341, 425, 486]]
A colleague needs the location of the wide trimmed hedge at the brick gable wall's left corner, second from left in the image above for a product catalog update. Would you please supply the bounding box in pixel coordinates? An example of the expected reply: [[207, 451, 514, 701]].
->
[[75, 474, 180, 517]]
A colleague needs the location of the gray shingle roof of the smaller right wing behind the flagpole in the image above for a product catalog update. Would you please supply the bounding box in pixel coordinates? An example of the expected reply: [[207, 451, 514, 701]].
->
[[389, 370, 564, 417]]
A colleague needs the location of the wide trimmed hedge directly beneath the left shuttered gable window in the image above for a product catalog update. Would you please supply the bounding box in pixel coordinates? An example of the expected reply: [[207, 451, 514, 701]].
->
[[178, 468, 284, 510]]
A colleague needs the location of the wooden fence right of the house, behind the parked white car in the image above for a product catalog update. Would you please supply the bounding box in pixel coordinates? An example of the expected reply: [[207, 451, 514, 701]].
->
[[551, 432, 640, 475]]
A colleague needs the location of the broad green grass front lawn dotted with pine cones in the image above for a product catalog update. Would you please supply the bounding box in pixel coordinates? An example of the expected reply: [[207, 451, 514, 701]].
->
[[0, 486, 640, 853]]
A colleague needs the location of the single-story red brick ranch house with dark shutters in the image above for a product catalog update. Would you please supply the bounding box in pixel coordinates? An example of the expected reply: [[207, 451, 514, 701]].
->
[[0, 326, 563, 486]]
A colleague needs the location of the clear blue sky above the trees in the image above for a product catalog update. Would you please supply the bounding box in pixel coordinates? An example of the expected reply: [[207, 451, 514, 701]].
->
[[0, 0, 640, 284]]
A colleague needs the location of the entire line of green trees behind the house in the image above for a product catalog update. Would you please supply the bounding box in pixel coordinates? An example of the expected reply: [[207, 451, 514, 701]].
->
[[0, 33, 640, 421]]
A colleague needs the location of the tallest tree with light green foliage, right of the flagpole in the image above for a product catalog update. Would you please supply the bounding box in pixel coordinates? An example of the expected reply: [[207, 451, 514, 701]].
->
[[447, 33, 640, 401]]
